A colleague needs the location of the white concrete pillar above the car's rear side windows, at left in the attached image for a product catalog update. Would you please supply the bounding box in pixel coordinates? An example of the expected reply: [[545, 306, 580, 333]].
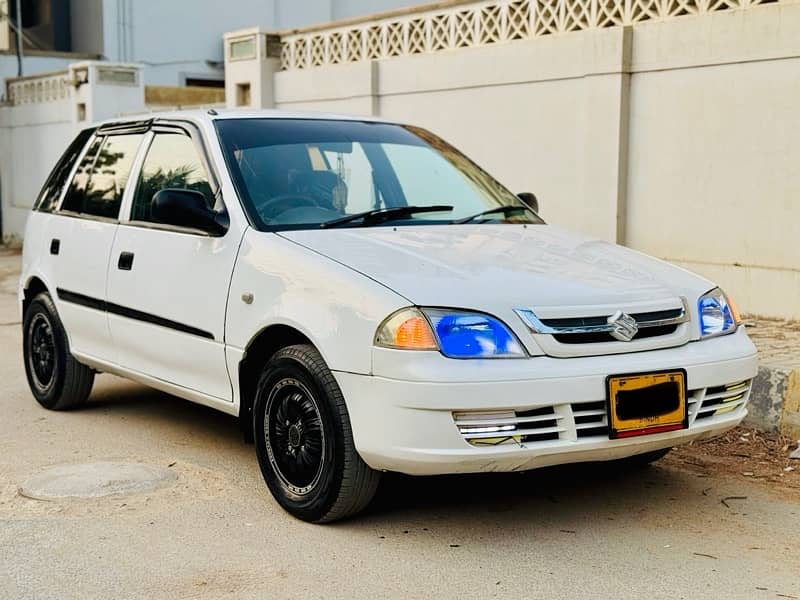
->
[[69, 61, 147, 127]]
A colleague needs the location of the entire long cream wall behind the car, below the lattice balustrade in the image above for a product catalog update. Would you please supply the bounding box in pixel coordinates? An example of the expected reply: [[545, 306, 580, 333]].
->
[[238, 1, 800, 319]]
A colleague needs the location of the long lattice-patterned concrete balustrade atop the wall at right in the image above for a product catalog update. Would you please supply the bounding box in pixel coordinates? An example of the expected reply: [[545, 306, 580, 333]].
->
[[280, 0, 794, 70]]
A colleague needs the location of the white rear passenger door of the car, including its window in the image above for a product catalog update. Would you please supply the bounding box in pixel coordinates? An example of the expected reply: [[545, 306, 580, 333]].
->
[[45, 131, 144, 362]]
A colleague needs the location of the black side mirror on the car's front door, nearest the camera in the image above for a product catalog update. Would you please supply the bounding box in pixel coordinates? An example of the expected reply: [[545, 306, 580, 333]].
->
[[150, 188, 229, 235]]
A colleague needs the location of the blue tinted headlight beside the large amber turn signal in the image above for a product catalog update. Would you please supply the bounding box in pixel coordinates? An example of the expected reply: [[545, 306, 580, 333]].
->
[[423, 309, 525, 358]]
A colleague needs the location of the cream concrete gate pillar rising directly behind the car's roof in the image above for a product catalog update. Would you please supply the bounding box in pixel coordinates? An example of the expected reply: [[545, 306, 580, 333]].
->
[[225, 27, 281, 108]]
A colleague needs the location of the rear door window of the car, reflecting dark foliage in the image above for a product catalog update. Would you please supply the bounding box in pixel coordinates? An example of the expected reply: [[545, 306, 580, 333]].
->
[[62, 133, 143, 219]]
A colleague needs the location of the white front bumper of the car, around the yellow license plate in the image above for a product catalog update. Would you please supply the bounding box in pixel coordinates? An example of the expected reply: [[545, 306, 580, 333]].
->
[[335, 329, 758, 475]]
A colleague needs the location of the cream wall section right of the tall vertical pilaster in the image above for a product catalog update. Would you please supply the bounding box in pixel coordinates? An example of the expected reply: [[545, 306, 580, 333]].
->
[[627, 5, 800, 318]]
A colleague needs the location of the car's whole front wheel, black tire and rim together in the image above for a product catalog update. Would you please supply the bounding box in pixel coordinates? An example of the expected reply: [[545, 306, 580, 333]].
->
[[253, 344, 381, 523]]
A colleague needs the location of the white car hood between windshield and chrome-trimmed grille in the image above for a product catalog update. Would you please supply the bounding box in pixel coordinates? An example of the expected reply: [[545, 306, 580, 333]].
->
[[279, 224, 713, 314]]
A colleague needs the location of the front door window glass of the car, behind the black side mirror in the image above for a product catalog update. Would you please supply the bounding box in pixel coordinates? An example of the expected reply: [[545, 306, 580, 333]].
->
[[131, 133, 214, 222]]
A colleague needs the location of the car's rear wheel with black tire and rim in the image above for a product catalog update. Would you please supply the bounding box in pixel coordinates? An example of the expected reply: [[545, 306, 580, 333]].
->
[[22, 292, 94, 410]]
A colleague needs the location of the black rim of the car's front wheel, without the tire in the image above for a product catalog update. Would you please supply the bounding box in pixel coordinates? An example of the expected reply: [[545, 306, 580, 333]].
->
[[264, 378, 325, 496]]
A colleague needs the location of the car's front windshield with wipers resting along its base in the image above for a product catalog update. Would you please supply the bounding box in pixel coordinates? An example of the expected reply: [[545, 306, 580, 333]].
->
[[216, 118, 542, 231]]
